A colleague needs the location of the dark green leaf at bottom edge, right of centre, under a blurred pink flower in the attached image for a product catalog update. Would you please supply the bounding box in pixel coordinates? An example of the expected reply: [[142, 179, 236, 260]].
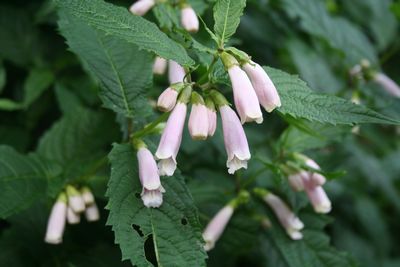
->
[[268, 215, 358, 267]]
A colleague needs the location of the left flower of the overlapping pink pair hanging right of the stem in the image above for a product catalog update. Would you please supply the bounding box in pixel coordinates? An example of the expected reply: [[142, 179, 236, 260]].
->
[[221, 52, 263, 123]]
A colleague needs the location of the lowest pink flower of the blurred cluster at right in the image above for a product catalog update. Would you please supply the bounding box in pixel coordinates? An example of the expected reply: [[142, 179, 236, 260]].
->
[[302, 174, 332, 213]]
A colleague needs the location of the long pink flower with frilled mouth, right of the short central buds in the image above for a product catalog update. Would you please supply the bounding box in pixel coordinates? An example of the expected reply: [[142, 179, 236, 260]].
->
[[219, 105, 251, 174]]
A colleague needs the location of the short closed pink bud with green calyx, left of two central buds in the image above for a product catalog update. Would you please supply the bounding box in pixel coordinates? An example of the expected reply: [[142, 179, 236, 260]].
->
[[189, 92, 209, 140]]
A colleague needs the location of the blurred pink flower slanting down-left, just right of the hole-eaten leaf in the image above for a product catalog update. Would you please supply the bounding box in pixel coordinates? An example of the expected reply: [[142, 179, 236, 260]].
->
[[203, 205, 234, 251]]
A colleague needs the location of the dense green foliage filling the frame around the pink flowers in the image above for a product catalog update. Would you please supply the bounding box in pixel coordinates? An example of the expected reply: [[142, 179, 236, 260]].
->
[[0, 0, 400, 267]]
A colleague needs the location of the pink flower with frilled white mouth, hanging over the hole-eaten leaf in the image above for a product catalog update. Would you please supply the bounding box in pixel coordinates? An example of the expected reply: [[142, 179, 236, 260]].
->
[[137, 147, 165, 208]]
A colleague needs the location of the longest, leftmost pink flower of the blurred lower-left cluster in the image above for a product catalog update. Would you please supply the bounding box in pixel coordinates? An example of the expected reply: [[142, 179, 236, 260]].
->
[[44, 193, 67, 244]]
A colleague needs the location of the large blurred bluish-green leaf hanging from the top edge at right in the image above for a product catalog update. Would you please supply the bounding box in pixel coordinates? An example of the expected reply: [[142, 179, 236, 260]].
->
[[282, 0, 378, 66]]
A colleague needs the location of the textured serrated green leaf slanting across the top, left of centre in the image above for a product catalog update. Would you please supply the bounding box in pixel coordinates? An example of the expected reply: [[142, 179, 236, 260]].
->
[[56, 0, 194, 66]]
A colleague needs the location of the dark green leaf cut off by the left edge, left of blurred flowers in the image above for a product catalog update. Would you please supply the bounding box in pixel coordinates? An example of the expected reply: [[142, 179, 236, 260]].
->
[[0, 146, 49, 218]]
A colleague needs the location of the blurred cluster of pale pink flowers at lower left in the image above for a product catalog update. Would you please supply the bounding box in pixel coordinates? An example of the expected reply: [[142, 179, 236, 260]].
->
[[45, 185, 100, 244]]
